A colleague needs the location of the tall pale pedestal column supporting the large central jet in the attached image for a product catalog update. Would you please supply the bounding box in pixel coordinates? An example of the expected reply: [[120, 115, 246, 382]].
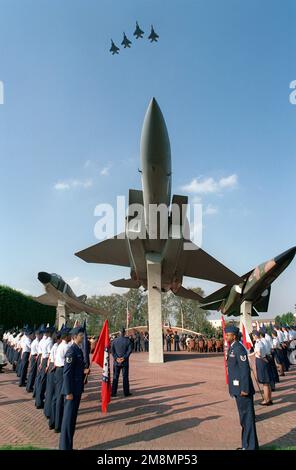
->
[[146, 254, 163, 364]]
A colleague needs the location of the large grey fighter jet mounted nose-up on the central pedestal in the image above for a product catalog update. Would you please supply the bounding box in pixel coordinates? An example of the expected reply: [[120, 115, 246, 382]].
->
[[75, 98, 243, 300]]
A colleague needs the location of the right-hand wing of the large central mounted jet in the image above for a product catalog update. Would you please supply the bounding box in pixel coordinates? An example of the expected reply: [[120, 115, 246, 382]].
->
[[181, 240, 243, 286]]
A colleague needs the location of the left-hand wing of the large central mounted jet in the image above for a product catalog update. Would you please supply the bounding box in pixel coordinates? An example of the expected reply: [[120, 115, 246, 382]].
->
[[75, 234, 130, 267]]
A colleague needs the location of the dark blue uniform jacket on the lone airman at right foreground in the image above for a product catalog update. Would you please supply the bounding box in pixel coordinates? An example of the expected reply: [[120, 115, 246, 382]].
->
[[227, 341, 255, 397]]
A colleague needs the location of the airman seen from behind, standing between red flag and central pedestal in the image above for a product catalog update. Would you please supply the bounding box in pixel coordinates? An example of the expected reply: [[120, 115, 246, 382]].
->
[[111, 328, 132, 397]]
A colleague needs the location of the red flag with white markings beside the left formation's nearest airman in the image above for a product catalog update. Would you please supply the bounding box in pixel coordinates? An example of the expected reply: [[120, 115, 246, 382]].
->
[[92, 320, 111, 413]]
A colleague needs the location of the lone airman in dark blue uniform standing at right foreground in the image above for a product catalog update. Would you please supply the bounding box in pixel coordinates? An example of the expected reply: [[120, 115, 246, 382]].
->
[[225, 325, 258, 450]]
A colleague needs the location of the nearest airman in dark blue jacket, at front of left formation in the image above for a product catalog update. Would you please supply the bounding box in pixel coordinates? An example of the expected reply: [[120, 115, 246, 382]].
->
[[59, 327, 87, 450]]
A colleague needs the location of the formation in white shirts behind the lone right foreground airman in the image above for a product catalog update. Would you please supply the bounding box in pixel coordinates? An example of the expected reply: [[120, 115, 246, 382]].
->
[[252, 326, 296, 406]]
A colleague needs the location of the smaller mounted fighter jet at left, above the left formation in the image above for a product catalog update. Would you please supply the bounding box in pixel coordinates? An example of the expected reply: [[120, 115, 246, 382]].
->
[[35, 272, 105, 314]]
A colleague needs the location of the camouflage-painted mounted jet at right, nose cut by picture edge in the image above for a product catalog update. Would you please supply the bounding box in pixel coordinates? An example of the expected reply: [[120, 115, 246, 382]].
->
[[200, 247, 296, 316]]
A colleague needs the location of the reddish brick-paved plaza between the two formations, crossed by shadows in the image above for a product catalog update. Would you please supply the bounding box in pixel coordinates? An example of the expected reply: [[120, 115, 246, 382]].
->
[[0, 352, 296, 450]]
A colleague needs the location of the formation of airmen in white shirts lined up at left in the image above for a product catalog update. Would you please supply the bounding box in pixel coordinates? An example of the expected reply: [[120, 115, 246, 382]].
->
[[3, 325, 89, 450]]
